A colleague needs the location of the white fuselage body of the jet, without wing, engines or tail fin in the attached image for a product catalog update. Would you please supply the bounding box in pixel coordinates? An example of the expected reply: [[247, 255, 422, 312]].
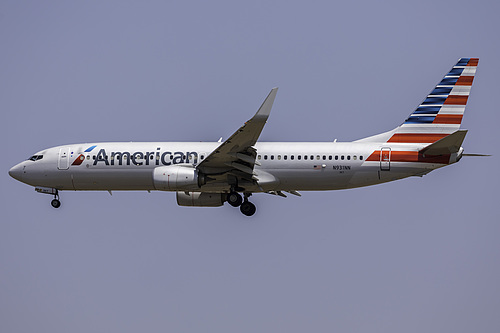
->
[[10, 142, 458, 192]]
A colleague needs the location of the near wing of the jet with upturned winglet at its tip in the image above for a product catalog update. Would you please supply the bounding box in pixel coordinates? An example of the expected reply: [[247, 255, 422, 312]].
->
[[198, 88, 278, 180]]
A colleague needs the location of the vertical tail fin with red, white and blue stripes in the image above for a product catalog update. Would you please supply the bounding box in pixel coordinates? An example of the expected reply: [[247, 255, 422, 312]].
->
[[359, 58, 479, 144]]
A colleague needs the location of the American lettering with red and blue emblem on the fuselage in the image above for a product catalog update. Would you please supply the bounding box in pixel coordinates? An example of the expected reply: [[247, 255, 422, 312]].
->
[[72, 146, 198, 166]]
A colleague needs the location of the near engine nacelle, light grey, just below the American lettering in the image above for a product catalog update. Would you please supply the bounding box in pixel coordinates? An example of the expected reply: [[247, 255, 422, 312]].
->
[[153, 164, 205, 191]]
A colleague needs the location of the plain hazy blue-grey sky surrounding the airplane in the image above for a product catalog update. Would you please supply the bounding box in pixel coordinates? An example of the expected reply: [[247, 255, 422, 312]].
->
[[0, 0, 500, 333]]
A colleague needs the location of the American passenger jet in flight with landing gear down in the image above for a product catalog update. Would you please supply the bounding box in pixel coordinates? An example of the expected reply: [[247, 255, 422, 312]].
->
[[9, 58, 479, 216]]
